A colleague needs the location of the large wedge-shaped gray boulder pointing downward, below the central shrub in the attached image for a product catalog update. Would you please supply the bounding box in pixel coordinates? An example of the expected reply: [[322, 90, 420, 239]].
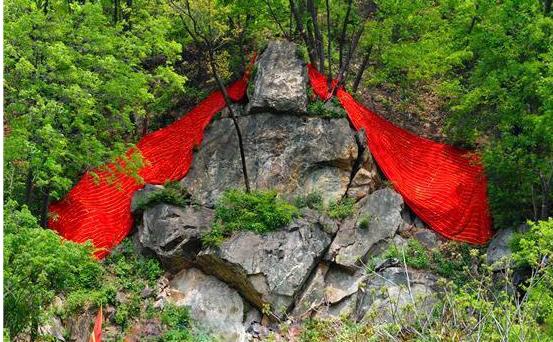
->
[[197, 214, 330, 316]]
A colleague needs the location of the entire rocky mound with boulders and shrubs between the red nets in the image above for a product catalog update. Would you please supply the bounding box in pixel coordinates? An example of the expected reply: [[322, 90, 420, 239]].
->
[[32, 41, 544, 342]]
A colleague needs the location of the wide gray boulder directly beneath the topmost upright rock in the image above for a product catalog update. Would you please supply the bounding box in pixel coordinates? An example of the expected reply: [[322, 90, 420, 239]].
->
[[181, 113, 358, 206]]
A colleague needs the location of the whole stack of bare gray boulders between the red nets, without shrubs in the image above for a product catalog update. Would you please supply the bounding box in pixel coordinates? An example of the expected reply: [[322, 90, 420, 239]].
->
[[130, 42, 441, 341]]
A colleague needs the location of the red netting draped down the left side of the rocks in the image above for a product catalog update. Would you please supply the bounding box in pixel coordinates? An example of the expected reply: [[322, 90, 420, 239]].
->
[[49, 73, 248, 258]]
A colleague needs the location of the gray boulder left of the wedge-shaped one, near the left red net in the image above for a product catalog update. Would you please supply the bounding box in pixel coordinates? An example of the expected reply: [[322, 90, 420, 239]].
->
[[138, 204, 213, 271]]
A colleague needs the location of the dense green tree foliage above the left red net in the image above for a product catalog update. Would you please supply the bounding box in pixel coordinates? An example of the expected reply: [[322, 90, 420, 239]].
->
[[4, 0, 186, 211]]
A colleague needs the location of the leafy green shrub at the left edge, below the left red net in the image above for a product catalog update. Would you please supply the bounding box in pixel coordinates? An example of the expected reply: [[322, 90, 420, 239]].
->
[[4, 201, 105, 337]]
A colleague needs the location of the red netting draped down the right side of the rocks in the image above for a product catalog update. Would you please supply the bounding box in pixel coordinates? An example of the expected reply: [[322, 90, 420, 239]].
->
[[309, 66, 492, 244]]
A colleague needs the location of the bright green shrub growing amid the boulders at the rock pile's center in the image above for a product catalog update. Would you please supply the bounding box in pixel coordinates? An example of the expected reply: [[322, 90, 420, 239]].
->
[[202, 189, 298, 246]]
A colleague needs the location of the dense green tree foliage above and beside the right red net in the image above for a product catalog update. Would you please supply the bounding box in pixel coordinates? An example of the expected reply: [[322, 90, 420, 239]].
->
[[344, 0, 553, 227]]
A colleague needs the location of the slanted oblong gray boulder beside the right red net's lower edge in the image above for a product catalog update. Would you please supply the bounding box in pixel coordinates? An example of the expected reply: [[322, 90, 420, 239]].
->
[[326, 188, 404, 272]]
